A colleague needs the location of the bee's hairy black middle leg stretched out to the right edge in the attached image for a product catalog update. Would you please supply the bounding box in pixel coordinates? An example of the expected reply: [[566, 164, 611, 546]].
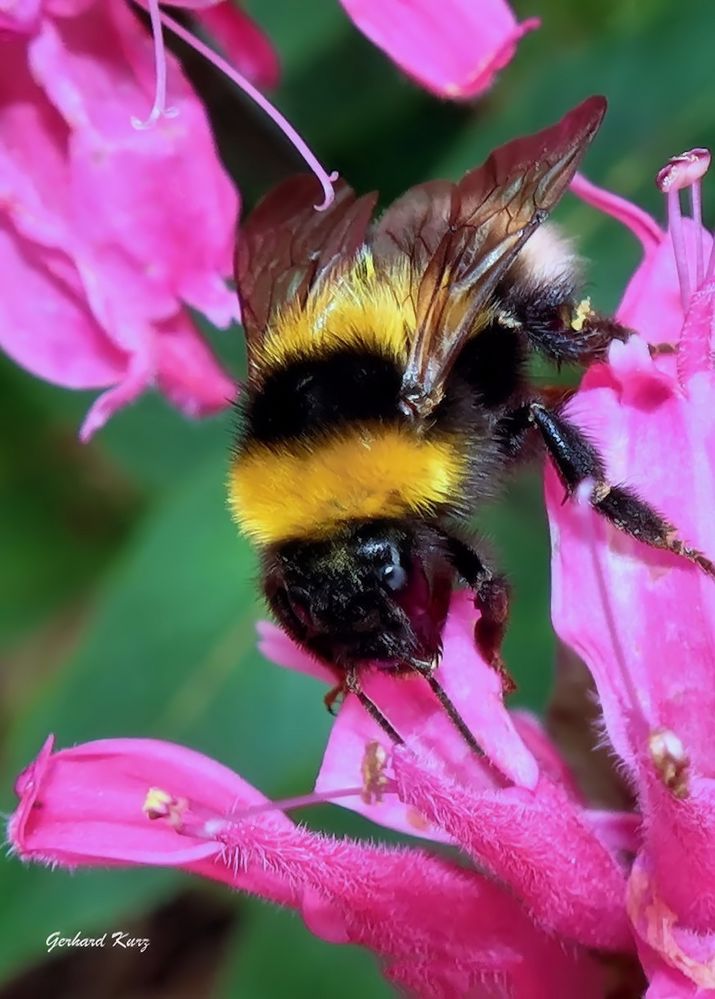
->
[[529, 402, 715, 576]]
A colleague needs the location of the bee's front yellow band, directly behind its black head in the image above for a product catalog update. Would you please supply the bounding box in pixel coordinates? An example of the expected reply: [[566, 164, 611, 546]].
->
[[228, 426, 465, 545]]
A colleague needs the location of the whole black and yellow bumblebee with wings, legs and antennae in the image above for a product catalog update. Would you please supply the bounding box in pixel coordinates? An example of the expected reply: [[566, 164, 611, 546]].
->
[[229, 97, 712, 748]]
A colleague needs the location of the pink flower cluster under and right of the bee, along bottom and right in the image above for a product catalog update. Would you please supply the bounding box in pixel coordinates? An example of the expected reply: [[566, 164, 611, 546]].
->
[[9, 151, 715, 999]]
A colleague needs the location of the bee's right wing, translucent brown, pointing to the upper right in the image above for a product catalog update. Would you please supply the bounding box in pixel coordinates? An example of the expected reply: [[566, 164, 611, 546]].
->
[[372, 97, 606, 419]]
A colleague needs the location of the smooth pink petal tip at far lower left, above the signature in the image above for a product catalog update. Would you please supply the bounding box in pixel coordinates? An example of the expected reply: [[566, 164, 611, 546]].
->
[[8, 739, 291, 866]]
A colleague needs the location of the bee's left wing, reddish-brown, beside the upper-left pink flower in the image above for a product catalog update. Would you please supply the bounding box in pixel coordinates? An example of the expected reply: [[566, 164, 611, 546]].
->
[[234, 174, 377, 381]]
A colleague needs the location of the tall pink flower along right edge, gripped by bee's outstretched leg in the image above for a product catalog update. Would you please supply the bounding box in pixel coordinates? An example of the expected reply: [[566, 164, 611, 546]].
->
[[546, 156, 715, 997]]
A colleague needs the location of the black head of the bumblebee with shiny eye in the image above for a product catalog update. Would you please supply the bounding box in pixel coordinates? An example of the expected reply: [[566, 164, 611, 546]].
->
[[265, 521, 454, 668]]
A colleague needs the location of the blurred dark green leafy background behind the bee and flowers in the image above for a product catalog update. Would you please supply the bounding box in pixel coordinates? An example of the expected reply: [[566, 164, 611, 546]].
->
[[0, 0, 715, 999]]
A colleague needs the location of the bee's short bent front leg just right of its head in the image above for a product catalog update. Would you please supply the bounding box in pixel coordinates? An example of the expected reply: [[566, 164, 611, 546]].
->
[[447, 537, 516, 694]]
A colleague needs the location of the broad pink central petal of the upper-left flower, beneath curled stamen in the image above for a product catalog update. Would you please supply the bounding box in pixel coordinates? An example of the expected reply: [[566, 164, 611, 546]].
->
[[31, 0, 237, 324]]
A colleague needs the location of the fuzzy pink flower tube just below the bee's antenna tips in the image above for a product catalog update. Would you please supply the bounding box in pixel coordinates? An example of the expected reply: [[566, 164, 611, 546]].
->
[[393, 746, 631, 950]]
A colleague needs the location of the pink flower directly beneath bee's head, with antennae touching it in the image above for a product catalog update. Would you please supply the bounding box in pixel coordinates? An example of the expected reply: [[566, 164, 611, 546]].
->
[[261, 593, 633, 950]]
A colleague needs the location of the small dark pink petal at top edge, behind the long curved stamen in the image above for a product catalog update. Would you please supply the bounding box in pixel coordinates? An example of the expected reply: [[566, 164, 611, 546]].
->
[[194, 0, 281, 89]]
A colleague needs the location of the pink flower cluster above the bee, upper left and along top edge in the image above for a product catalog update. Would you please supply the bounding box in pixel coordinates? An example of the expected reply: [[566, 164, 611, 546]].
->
[[0, 0, 535, 440]]
